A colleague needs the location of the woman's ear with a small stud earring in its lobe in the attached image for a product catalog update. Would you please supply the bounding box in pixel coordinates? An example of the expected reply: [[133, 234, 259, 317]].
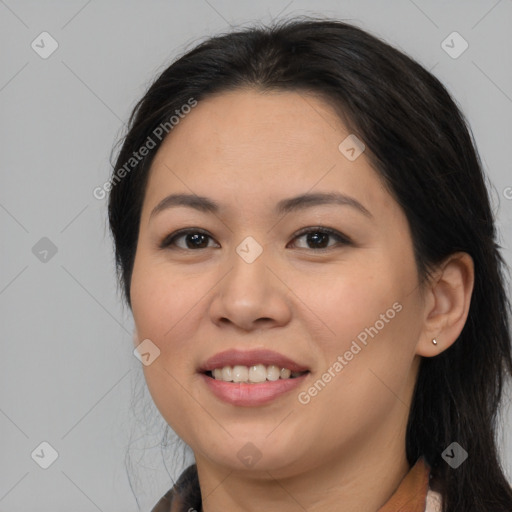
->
[[416, 252, 475, 357]]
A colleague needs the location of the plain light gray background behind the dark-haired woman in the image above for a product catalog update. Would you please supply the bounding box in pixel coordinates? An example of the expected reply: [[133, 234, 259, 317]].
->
[[0, 0, 512, 512]]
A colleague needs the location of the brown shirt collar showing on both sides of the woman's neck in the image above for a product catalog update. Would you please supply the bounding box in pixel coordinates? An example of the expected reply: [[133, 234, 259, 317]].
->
[[151, 457, 434, 512]]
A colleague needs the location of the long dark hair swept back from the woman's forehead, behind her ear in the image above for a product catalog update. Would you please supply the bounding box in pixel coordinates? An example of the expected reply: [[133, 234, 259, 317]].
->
[[108, 18, 512, 512]]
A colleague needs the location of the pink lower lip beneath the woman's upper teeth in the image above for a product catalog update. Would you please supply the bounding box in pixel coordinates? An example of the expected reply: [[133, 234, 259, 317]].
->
[[201, 373, 309, 407]]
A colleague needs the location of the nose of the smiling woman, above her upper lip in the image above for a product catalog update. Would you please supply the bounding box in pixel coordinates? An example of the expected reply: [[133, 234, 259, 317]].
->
[[210, 244, 291, 331]]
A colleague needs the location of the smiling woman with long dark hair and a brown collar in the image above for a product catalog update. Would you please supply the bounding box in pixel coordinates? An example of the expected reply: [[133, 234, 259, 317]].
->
[[109, 20, 512, 512]]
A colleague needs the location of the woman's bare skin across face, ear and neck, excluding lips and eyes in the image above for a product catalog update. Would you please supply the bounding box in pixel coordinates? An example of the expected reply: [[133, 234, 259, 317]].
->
[[131, 89, 473, 512]]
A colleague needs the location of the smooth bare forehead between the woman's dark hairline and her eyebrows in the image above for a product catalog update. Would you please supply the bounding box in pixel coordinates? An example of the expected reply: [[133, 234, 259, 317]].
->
[[147, 89, 389, 218]]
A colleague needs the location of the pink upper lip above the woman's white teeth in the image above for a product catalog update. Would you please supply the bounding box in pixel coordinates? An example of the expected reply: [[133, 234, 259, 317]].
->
[[199, 349, 309, 373]]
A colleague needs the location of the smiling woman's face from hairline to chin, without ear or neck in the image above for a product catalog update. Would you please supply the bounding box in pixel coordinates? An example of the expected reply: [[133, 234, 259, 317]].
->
[[131, 90, 423, 476]]
